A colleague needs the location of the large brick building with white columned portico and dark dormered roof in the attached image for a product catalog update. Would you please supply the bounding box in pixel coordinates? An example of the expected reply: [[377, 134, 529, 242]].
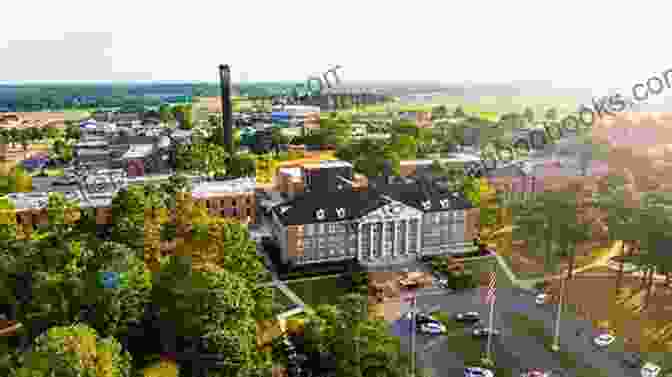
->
[[272, 176, 479, 265]]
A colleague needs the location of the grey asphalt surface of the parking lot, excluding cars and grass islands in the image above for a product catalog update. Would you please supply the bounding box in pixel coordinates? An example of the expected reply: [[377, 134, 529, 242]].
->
[[393, 288, 639, 377]]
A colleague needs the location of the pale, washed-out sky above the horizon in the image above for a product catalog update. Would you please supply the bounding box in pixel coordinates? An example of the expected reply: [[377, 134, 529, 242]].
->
[[0, 0, 672, 98]]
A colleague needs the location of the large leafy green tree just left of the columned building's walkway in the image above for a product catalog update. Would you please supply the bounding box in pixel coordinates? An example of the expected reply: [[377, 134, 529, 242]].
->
[[153, 256, 258, 376]]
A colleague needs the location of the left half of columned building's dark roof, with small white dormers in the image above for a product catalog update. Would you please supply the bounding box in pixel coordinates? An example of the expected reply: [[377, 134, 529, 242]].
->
[[273, 190, 388, 225]]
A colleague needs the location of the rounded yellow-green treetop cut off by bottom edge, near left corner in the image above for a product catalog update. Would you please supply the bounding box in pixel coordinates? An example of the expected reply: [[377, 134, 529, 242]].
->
[[11, 324, 132, 377]]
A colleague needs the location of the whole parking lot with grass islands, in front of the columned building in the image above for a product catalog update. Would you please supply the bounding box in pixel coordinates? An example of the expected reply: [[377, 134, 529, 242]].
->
[[392, 288, 640, 377]]
